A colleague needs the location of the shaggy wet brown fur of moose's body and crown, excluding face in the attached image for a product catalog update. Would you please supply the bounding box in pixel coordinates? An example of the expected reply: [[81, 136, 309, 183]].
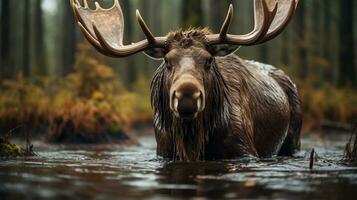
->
[[151, 29, 302, 161]]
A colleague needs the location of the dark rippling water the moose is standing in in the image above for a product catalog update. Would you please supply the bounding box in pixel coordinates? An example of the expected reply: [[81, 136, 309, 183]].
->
[[0, 130, 357, 200]]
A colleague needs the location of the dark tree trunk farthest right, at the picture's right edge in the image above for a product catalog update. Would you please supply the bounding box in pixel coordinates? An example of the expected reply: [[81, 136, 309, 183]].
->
[[339, 0, 357, 86]]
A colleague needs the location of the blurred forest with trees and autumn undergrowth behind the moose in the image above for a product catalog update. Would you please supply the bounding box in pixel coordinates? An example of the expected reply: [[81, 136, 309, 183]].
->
[[0, 0, 357, 141]]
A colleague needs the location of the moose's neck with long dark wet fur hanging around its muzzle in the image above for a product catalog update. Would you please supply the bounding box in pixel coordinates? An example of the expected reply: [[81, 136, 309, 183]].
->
[[151, 61, 231, 161]]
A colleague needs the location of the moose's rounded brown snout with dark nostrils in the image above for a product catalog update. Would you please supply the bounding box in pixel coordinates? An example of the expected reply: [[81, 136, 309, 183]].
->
[[171, 82, 204, 119]]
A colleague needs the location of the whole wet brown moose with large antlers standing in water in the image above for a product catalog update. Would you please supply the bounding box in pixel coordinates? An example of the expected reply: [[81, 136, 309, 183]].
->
[[71, 0, 302, 161]]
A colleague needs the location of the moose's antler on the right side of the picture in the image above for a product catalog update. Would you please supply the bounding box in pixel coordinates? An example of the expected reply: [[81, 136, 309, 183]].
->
[[207, 0, 299, 46]]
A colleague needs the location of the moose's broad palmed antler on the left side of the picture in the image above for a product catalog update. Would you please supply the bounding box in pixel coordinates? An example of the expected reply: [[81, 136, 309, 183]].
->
[[71, 0, 166, 57]]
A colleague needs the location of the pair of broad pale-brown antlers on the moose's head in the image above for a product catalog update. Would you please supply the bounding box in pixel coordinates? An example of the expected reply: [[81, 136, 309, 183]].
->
[[70, 0, 299, 57]]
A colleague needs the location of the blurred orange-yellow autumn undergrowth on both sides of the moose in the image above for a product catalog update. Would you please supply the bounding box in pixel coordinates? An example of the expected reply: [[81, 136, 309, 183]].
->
[[0, 45, 357, 143]]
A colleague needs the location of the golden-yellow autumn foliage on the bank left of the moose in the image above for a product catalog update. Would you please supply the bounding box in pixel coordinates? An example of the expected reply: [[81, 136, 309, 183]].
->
[[0, 50, 152, 141]]
